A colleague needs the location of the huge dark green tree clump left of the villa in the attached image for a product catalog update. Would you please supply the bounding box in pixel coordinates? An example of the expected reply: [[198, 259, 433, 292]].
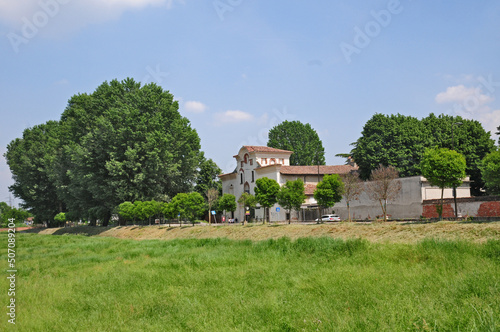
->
[[5, 79, 202, 225]]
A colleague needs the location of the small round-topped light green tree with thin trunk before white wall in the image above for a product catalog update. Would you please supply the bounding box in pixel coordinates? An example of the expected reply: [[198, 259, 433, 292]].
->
[[420, 148, 466, 219]]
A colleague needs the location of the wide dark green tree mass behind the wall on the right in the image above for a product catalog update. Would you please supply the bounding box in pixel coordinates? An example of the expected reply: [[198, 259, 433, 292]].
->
[[351, 114, 494, 195]]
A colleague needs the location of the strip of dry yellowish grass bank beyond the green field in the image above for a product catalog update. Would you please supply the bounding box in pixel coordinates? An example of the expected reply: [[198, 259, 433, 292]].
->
[[22, 221, 500, 243]]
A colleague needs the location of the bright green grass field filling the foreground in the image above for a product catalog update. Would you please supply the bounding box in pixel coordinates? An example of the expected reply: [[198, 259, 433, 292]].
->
[[0, 234, 500, 331]]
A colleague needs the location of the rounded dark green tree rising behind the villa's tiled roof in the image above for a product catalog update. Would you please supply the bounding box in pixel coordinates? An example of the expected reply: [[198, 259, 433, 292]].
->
[[267, 120, 325, 165]]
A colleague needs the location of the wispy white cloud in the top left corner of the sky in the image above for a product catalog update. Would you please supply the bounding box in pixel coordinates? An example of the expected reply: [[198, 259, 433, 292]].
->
[[0, 0, 184, 39]]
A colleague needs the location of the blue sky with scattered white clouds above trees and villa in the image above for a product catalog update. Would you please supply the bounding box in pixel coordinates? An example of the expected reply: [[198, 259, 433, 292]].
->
[[0, 0, 500, 208]]
